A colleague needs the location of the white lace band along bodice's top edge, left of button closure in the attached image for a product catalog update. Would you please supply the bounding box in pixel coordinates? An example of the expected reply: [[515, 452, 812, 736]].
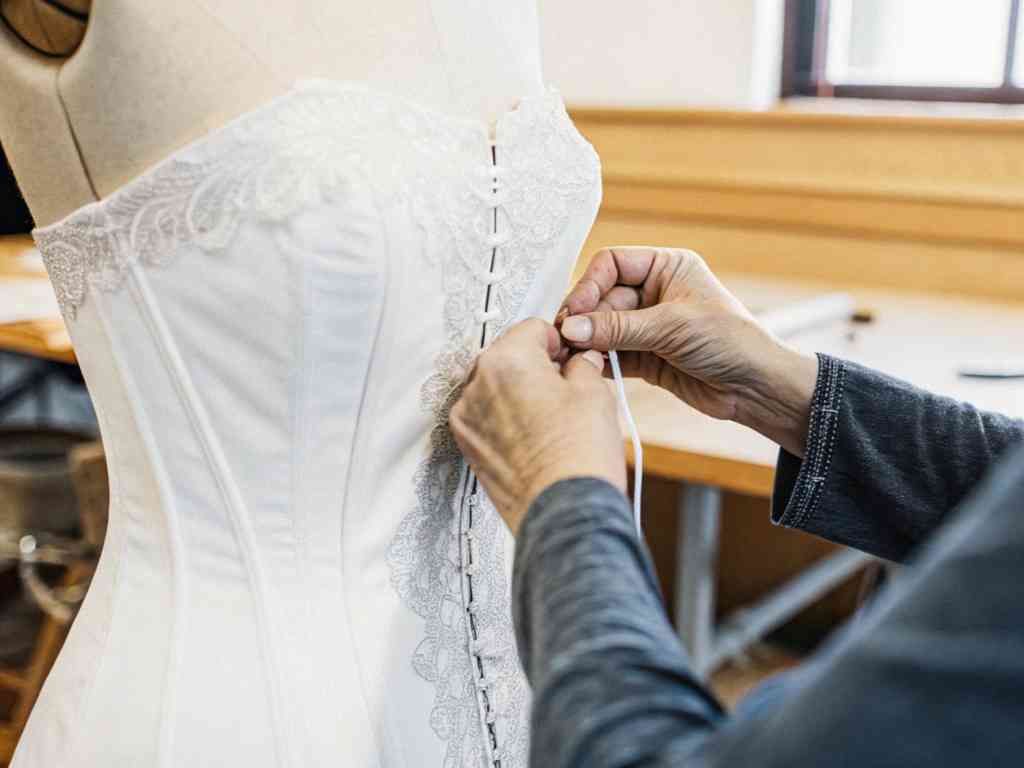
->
[[33, 81, 491, 321]]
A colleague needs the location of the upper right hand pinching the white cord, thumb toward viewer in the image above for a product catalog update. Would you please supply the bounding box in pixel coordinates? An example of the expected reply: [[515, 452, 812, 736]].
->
[[559, 247, 817, 456]]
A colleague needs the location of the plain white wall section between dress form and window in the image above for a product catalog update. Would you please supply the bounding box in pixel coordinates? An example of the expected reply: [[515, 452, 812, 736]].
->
[[540, 0, 783, 109]]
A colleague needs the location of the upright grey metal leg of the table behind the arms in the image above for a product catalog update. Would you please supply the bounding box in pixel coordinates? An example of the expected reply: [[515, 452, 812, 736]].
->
[[676, 484, 722, 677]]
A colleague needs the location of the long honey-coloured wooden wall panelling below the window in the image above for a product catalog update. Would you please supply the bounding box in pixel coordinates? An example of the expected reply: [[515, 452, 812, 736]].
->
[[572, 109, 1024, 301]]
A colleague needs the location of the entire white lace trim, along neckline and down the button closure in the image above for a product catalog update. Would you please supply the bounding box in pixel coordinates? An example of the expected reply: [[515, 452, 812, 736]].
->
[[35, 83, 600, 768]]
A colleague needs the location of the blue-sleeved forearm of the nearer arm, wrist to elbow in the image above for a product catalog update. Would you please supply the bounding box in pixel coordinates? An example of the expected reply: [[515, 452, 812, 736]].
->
[[514, 478, 724, 768]]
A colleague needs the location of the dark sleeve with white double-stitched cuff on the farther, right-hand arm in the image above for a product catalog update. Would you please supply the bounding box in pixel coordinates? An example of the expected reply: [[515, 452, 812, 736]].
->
[[772, 354, 1024, 561]]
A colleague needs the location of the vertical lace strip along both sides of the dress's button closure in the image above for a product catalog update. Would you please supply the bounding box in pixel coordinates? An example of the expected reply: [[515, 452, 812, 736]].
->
[[389, 91, 600, 768]]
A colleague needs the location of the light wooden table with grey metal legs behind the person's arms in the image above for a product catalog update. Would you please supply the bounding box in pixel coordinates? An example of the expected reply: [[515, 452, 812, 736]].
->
[[628, 274, 1024, 673]]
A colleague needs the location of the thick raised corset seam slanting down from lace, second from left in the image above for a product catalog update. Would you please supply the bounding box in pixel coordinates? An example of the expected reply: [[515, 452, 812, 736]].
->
[[128, 263, 290, 765]]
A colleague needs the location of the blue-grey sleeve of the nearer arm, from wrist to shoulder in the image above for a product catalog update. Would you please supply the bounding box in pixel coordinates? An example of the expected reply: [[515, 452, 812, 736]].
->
[[513, 452, 1024, 768]]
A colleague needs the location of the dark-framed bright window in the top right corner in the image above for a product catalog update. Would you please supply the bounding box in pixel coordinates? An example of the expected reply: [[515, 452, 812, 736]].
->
[[782, 0, 1024, 103]]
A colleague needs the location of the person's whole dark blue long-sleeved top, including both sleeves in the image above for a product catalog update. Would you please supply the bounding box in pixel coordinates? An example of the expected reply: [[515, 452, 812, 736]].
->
[[513, 356, 1024, 768]]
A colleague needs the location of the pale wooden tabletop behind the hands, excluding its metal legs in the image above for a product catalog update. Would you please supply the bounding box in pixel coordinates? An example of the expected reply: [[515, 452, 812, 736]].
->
[[628, 273, 1024, 497]]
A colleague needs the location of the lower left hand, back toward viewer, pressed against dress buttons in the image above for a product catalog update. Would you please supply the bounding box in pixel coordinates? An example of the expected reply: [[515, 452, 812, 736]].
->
[[449, 318, 626, 535]]
